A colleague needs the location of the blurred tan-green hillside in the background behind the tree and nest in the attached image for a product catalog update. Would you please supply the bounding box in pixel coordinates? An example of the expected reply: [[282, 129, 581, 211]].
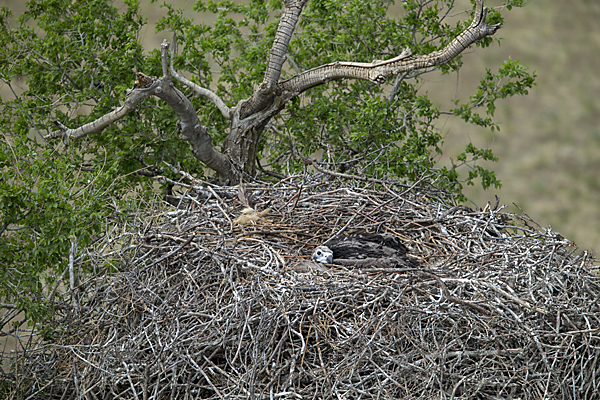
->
[[0, 0, 600, 250]]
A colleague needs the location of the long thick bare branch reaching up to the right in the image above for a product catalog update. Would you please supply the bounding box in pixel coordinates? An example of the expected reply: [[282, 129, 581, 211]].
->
[[277, 0, 500, 93]]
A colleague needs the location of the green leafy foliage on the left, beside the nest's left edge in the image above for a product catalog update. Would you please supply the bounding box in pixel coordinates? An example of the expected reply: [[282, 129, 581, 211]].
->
[[0, 0, 157, 321]]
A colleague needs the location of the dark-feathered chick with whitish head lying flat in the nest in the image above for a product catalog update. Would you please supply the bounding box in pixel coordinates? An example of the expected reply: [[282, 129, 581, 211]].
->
[[312, 233, 419, 268]]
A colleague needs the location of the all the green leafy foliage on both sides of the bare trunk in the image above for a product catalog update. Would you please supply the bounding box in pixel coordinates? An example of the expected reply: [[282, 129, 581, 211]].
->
[[0, 0, 534, 321]]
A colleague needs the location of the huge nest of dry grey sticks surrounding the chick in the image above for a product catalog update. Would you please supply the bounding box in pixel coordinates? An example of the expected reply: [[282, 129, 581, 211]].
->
[[3, 177, 600, 400]]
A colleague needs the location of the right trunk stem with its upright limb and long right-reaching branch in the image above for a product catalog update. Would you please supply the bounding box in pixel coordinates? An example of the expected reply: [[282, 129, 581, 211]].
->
[[223, 0, 500, 180]]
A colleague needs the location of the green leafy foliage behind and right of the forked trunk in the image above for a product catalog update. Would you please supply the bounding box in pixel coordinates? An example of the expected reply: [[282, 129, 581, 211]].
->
[[157, 0, 535, 192]]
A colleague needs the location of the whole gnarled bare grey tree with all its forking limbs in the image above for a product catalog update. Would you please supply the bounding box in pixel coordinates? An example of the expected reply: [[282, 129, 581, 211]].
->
[[46, 0, 500, 184]]
